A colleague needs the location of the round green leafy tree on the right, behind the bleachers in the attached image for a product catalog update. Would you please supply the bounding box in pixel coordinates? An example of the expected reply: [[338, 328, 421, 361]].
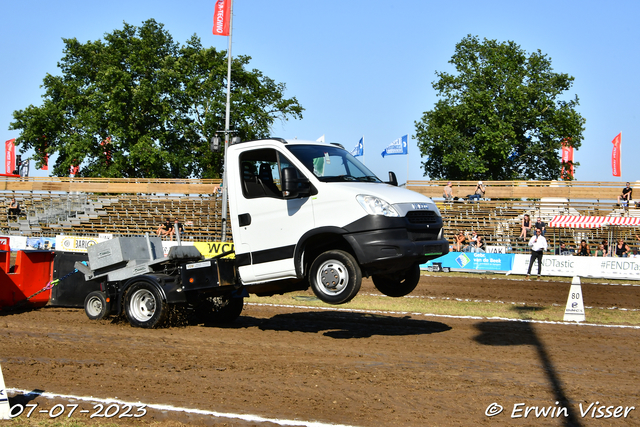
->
[[415, 35, 585, 180]]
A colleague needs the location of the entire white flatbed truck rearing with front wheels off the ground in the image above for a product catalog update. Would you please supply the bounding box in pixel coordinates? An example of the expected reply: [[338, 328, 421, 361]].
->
[[76, 138, 449, 327]]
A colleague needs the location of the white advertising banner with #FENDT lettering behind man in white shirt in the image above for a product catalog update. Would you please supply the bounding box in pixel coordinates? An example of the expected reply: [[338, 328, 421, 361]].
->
[[510, 255, 640, 280]]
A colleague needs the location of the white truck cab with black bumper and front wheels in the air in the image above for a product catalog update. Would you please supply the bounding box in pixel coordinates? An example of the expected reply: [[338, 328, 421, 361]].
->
[[226, 138, 449, 304]]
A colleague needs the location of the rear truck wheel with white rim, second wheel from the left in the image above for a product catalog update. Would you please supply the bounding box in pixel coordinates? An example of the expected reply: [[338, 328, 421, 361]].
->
[[124, 282, 168, 328]]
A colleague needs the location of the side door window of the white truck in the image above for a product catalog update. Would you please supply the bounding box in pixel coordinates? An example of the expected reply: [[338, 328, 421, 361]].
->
[[240, 148, 300, 199]]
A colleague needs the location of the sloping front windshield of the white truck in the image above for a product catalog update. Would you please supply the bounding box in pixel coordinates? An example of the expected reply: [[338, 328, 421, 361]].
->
[[287, 144, 382, 182]]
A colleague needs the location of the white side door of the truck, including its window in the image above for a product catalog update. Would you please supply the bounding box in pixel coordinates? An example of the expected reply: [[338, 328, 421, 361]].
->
[[234, 148, 315, 283]]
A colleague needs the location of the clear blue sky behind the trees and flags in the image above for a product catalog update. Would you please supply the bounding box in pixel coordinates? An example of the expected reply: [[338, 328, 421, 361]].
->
[[0, 0, 640, 186]]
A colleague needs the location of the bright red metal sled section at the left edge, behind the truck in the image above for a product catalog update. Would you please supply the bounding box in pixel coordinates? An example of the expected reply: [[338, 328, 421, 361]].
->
[[0, 238, 54, 310]]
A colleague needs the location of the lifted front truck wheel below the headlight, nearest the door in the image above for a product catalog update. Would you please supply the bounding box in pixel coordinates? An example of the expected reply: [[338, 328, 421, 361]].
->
[[309, 250, 362, 304]]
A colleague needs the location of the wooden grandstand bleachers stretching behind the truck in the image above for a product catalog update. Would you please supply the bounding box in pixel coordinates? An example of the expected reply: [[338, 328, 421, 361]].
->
[[0, 178, 640, 252]]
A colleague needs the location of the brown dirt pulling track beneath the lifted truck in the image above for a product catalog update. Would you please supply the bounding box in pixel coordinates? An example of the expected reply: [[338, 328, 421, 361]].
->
[[0, 276, 640, 426]]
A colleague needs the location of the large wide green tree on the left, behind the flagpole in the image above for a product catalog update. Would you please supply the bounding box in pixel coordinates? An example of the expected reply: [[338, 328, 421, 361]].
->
[[10, 19, 304, 178]]
